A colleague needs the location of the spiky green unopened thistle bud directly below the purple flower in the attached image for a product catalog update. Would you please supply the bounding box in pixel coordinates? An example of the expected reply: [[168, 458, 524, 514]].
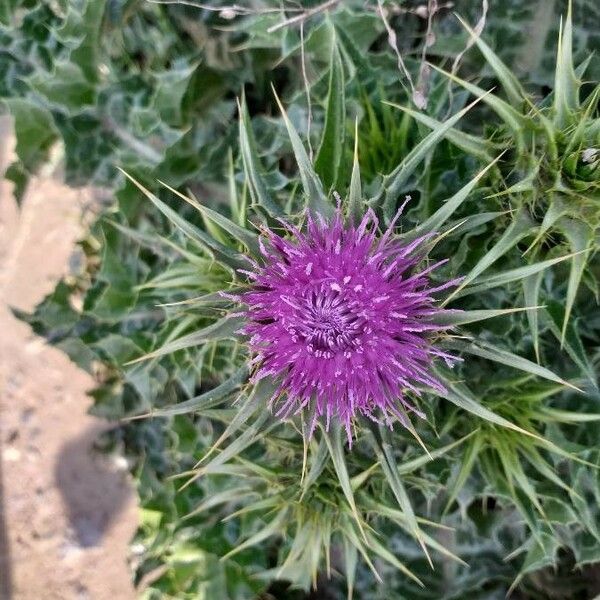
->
[[187, 427, 474, 596]]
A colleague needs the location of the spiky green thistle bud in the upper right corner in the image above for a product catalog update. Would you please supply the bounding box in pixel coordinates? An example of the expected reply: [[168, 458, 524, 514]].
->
[[400, 2, 600, 352]]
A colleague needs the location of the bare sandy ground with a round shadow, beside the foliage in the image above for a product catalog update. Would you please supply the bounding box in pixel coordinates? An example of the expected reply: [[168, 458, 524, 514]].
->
[[0, 119, 137, 600]]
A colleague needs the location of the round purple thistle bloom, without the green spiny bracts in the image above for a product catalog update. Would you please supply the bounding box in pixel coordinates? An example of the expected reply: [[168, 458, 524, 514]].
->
[[238, 207, 458, 444]]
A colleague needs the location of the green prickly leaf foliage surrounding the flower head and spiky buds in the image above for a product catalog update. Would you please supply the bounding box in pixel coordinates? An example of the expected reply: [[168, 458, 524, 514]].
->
[[0, 0, 600, 599]]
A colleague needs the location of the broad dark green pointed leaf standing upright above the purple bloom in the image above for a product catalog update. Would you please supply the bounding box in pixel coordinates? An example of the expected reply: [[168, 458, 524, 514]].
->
[[315, 31, 346, 189]]
